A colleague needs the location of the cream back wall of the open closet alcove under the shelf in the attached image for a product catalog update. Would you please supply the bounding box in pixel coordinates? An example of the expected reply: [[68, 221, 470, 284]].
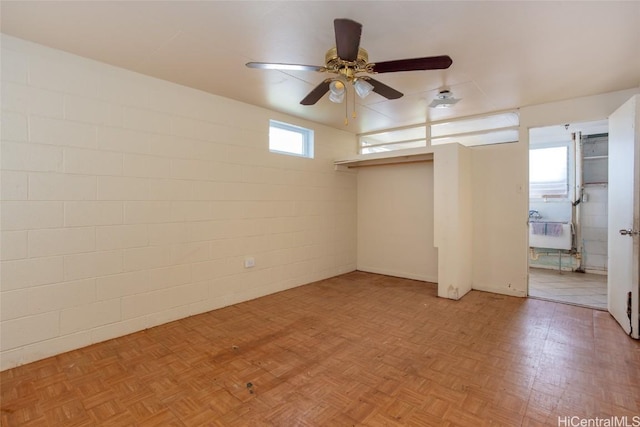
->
[[357, 162, 438, 282]]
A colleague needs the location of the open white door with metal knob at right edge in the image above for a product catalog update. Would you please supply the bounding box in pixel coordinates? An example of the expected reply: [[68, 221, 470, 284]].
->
[[608, 95, 640, 338]]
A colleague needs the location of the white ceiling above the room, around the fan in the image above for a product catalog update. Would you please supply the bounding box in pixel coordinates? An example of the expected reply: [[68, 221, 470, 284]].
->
[[0, 0, 640, 133]]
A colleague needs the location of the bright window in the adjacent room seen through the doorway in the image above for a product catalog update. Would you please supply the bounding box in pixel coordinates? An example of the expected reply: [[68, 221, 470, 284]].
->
[[529, 144, 569, 199]]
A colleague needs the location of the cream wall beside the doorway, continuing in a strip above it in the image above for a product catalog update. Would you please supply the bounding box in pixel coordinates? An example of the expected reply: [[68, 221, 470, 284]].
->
[[472, 88, 640, 296]]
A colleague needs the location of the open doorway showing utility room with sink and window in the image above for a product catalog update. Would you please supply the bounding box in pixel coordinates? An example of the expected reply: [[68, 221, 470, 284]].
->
[[529, 120, 608, 310]]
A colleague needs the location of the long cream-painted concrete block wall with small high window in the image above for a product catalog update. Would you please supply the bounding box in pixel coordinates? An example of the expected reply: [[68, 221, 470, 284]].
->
[[0, 36, 356, 369]]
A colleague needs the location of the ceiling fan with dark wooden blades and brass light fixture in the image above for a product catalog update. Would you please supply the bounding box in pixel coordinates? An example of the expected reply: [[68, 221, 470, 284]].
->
[[246, 19, 453, 105]]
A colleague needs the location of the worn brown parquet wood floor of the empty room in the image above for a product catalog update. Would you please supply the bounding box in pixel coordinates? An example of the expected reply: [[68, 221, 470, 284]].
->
[[0, 272, 640, 427]]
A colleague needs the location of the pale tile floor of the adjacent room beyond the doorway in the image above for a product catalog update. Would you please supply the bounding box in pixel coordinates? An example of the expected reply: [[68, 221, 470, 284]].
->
[[529, 268, 607, 310]]
